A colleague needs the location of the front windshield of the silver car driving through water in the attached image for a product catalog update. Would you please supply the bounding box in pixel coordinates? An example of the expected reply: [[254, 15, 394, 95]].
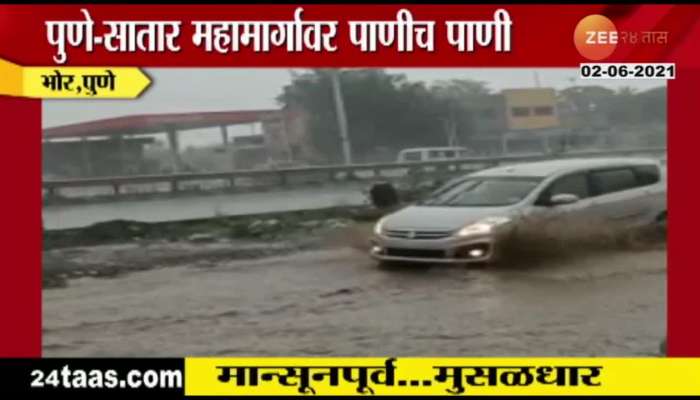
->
[[419, 177, 542, 207]]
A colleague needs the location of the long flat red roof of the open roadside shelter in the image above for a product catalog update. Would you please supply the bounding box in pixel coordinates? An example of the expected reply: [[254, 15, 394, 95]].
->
[[43, 110, 283, 139]]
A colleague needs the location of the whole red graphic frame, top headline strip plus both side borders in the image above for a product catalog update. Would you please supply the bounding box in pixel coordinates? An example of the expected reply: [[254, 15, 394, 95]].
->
[[0, 4, 700, 356]]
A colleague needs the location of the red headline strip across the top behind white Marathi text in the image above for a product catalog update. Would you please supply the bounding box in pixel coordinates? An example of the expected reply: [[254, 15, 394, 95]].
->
[[0, 5, 699, 67]]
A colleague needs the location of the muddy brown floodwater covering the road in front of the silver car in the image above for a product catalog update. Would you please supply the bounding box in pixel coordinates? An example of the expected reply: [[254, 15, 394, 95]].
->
[[43, 245, 666, 356]]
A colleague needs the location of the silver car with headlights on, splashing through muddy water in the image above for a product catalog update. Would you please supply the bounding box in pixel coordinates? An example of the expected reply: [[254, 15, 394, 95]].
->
[[370, 158, 666, 263]]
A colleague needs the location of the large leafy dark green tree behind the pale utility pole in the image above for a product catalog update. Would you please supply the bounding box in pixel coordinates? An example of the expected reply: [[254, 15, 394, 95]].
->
[[278, 69, 488, 162]]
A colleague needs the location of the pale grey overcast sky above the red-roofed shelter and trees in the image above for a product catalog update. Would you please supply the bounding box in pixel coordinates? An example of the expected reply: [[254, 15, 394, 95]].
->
[[43, 68, 665, 146]]
